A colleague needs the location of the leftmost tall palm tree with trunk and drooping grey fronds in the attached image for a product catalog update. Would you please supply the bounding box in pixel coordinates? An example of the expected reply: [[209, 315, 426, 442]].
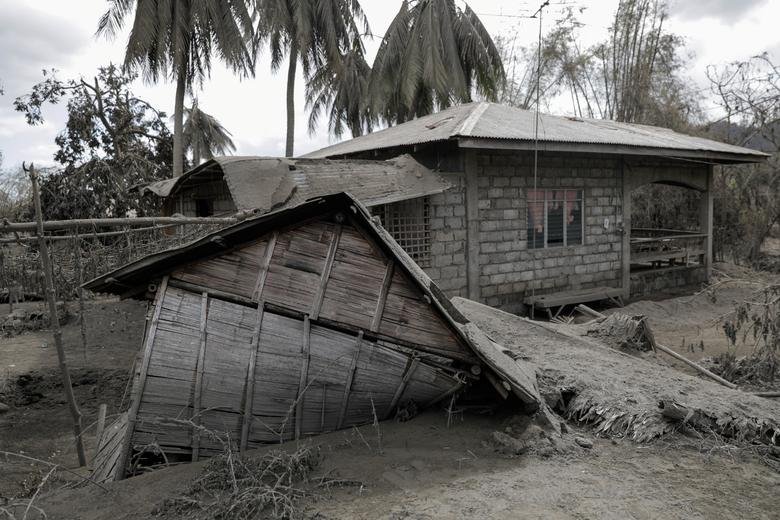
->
[[98, 0, 254, 176]]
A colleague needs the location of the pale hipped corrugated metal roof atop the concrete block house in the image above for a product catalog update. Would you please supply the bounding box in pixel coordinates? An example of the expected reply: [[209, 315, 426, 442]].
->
[[304, 102, 767, 162]]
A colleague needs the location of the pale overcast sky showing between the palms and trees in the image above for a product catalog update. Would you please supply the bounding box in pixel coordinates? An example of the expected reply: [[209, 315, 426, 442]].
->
[[0, 0, 780, 168]]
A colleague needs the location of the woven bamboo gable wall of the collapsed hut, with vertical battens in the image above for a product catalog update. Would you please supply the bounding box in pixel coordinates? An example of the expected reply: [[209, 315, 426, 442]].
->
[[122, 213, 474, 459]]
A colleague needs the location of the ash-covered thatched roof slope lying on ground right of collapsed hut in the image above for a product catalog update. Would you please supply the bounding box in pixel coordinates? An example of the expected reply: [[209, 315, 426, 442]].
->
[[453, 298, 780, 445]]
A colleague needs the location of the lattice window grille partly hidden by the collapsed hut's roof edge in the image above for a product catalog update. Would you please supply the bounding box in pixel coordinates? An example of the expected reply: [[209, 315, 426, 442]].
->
[[373, 197, 431, 267]]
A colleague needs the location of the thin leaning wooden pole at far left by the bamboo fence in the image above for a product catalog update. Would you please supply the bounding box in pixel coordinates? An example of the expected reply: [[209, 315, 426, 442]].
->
[[29, 164, 87, 466]]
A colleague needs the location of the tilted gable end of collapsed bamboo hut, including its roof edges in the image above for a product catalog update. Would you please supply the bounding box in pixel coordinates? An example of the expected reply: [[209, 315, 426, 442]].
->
[[85, 193, 544, 479]]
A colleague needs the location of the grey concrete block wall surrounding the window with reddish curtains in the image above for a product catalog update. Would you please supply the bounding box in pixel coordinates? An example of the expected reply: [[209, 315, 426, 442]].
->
[[477, 151, 622, 312]]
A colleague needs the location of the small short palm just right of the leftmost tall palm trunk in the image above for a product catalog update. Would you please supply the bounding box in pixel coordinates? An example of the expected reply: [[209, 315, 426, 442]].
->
[[183, 99, 236, 166]]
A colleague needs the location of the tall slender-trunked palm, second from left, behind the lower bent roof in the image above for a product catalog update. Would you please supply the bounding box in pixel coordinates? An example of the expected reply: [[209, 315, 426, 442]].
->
[[256, 0, 369, 157]]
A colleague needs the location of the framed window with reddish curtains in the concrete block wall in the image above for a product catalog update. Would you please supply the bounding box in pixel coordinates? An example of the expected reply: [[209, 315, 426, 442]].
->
[[528, 190, 584, 249]]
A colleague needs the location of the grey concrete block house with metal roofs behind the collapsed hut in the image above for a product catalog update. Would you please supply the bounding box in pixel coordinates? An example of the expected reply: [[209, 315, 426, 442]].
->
[[144, 102, 767, 315]]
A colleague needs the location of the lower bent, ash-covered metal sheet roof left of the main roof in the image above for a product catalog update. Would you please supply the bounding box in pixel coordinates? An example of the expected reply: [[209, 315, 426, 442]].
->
[[138, 155, 451, 211]]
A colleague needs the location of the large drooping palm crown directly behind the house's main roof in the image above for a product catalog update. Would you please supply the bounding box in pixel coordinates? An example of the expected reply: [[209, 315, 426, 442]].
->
[[370, 0, 504, 124]]
